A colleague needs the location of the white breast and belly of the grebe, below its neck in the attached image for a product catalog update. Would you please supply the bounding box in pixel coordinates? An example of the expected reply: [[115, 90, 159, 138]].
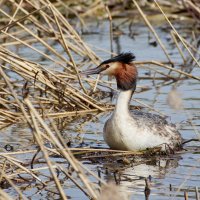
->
[[104, 115, 172, 151]]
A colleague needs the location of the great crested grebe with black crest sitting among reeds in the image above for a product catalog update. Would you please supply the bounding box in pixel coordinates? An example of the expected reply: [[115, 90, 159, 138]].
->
[[82, 53, 182, 151]]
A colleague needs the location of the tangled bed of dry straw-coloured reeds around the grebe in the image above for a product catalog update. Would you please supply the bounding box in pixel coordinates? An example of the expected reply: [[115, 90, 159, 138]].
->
[[0, 0, 200, 199]]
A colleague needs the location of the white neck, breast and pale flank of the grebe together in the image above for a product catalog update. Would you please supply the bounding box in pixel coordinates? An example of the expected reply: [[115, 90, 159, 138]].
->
[[104, 91, 181, 151]]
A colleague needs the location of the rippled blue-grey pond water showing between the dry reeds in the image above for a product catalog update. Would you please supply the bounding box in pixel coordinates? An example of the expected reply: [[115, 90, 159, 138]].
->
[[0, 19, 200, 200]]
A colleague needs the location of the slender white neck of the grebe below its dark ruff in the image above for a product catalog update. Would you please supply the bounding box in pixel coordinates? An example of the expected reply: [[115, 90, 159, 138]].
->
[[115, 89, 134, 116]]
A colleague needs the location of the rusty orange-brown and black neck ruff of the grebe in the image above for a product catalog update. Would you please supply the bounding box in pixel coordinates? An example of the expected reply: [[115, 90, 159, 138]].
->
[[115, 63, 138, 90]]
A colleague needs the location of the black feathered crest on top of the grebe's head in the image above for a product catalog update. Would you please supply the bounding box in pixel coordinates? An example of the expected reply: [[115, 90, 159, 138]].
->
[[101, 52, 135, 65]]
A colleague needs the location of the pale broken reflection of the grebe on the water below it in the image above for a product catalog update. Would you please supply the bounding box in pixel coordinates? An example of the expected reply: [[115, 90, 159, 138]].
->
[[101, 157, 181, 195]]
